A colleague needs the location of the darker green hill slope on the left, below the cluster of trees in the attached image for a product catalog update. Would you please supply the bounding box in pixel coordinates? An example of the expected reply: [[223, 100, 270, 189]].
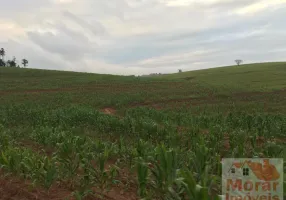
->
[[0, 67, 143, 90]]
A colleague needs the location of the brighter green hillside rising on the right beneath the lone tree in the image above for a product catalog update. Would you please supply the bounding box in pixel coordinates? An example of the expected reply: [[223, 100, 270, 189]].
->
[[160, 62, 286, 90]]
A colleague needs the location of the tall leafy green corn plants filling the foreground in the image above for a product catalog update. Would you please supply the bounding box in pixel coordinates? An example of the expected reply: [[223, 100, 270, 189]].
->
[[0, 104, 286, 199]]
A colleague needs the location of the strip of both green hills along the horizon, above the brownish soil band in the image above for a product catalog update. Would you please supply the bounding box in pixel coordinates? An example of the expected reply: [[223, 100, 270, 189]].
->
[[0, 62, 286, 92]]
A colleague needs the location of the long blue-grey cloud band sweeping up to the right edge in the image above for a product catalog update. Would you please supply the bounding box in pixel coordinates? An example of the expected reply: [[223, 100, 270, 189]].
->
[[98, 5, 286, 64]]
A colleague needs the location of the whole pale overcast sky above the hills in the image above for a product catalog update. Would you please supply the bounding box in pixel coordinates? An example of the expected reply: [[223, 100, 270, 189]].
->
[[0, 0, 286, 75]]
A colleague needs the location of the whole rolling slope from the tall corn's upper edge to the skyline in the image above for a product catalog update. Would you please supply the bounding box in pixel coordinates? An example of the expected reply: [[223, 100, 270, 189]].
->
[[0, 63, 286, 110]]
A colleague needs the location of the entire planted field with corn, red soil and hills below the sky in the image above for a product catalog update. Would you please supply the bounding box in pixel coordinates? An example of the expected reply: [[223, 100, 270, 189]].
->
[[0, 63, 286, 200]]
